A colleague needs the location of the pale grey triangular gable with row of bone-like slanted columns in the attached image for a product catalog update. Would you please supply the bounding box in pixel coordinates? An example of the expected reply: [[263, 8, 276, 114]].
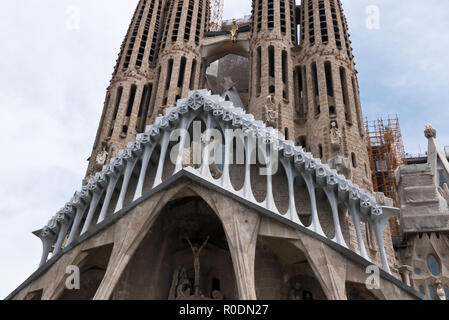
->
[[35, 90, 396, 273]]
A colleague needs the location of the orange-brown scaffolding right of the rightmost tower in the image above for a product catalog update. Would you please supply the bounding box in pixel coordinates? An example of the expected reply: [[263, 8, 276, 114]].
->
[[365, 115, 407, 237]]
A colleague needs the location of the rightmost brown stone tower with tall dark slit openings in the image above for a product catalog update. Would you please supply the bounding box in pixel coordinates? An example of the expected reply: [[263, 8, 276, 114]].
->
[[294, 0, 372, 190]]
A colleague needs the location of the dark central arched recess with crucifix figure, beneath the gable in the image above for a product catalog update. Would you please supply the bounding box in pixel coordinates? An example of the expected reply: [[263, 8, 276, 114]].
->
[[111, 196, 238, 300]]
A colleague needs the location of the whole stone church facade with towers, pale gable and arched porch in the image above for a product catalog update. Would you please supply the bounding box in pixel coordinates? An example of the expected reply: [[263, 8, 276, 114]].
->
[[8, 0, 449, 300]]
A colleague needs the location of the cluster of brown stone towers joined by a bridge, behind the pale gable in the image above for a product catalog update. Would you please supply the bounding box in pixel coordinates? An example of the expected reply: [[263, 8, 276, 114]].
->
[[86, 0, 372, 191]]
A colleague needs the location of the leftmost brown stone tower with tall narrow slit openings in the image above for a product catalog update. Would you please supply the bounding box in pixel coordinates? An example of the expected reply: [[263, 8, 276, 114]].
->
[[86, 0, 166, 176]]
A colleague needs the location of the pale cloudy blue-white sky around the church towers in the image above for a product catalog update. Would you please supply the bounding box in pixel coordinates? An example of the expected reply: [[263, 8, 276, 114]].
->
[[0, 0, 449, 298]]
